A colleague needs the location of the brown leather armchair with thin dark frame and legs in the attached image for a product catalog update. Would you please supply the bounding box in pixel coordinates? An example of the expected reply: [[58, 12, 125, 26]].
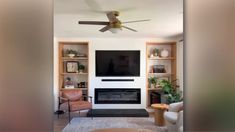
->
[[58, 89, 93, 123]]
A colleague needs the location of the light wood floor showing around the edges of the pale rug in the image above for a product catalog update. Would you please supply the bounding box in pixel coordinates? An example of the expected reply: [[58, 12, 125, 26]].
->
[[54, 111, 154, 132]]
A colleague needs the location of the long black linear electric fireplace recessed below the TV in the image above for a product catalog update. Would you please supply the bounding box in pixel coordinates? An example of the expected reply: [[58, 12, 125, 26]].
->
[[95, 88, 141, 104]]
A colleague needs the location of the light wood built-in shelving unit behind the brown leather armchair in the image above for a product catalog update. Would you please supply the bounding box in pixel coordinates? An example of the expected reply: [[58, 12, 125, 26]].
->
[[58, 41, 89, 94]]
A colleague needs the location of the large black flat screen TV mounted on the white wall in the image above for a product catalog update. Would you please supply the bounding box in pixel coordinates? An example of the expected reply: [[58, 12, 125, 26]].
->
[[96, 50, 140, 77]]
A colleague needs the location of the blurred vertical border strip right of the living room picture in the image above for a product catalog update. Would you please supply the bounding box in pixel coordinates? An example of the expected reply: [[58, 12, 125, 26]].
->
[[184, 0, 235, 132]]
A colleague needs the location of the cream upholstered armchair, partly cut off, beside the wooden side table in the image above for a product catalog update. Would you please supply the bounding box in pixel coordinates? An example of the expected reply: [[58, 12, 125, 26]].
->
[[164, 102, 183, 132]]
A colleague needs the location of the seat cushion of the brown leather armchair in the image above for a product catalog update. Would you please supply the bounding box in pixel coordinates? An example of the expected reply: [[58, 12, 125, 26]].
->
[[60, 101, 92, 111]]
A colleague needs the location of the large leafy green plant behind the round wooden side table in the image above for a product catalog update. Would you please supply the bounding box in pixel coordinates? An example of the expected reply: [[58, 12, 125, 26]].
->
[[158, 80, 181, 104]]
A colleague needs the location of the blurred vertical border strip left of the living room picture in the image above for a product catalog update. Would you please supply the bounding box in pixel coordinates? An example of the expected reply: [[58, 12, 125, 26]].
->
[[0, 0, 53, 132]]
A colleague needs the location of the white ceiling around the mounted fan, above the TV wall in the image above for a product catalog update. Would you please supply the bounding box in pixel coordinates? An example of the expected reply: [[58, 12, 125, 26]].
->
[[54, 0, 183, 38]]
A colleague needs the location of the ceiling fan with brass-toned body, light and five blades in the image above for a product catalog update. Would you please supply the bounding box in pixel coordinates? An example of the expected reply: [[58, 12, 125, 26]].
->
[[78, 11, 150, 33]]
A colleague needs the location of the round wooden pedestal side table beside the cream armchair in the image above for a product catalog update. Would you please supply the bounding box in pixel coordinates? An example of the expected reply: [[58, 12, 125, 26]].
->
[[151, 104, 169, 126]]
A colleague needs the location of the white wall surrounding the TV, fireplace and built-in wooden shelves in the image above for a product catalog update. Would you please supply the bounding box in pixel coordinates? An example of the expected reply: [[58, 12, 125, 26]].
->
[[54, 38, 182, 110]]
